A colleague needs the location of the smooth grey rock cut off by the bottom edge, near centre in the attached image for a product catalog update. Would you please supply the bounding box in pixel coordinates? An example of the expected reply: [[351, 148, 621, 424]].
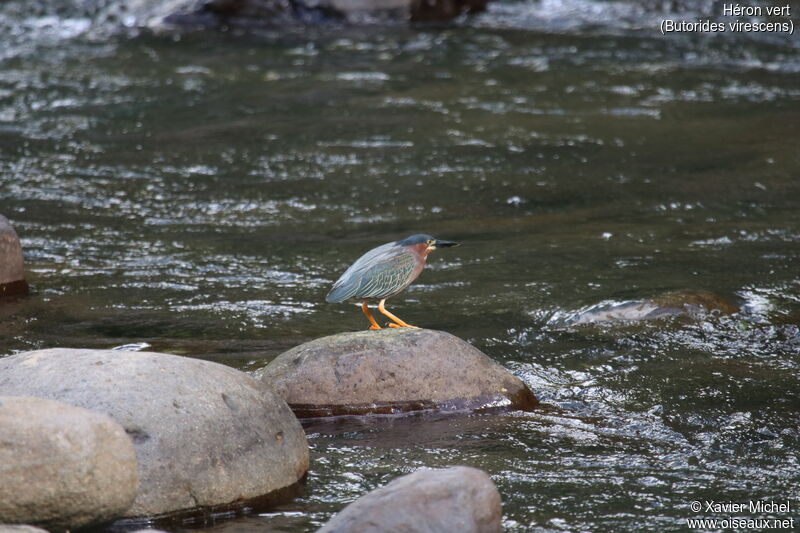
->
[[319, 466, 502, 533]]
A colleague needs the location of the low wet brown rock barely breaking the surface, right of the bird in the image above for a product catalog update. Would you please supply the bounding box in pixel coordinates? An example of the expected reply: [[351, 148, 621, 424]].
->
[[550, 291, 739, 326]]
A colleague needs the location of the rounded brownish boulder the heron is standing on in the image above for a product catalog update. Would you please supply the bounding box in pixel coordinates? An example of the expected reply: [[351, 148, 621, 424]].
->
[[257, 328, 538, 418]]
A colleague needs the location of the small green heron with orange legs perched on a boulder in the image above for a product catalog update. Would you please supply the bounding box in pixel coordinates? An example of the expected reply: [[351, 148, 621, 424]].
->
[[325, 234, 458, 329]]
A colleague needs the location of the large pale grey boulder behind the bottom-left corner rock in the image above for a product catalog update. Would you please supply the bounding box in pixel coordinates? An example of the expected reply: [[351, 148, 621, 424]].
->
[[0, 348, 308, 517]]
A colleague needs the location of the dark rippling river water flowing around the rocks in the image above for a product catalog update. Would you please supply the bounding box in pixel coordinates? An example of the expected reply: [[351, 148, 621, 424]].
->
[[0, 1, 800, 533]]
